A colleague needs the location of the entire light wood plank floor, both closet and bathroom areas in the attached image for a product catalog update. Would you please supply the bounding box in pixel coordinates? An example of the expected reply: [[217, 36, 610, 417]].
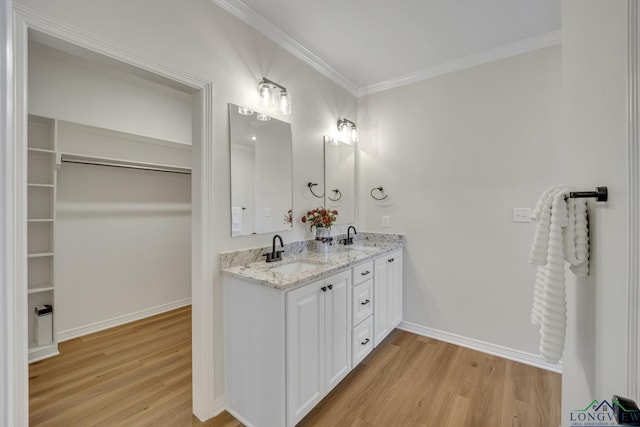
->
[[29, 307, 561, 427]]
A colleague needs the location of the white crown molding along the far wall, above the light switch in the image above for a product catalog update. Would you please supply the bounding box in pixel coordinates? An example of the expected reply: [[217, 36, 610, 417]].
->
[[358, 31, 561, 96]]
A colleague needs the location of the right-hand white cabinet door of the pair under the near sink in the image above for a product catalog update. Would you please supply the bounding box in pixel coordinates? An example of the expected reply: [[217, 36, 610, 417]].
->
[[324, 271, 351, 393]]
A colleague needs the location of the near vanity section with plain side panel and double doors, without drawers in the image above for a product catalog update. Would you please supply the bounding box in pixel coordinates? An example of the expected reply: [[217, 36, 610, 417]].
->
[[224, 269, 351, 427]]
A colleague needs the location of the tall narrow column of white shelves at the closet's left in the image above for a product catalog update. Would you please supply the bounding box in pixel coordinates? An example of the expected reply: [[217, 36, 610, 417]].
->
[[27, 115, 58, 362]]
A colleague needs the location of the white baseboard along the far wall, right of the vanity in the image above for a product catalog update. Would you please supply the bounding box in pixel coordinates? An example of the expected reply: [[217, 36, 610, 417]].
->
[[398, 322, 562, 374]]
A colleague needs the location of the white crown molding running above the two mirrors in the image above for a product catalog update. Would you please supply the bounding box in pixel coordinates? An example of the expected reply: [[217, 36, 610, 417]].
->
[[212, 0, 358, 96]]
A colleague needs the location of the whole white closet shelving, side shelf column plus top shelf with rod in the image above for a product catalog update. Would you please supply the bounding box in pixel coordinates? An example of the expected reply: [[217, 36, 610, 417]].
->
[[27, 115, 191, 362]]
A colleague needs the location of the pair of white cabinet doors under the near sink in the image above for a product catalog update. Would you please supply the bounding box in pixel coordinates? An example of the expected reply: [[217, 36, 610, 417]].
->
[[286, 271, 351, 425]]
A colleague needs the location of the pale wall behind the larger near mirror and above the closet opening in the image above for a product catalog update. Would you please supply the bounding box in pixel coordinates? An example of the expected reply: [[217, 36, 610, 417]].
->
[[20, 0, 357, 406]]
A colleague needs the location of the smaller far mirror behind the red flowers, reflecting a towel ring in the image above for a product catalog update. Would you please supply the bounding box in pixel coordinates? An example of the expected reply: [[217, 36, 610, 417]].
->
[[324, 136, 356, 225]]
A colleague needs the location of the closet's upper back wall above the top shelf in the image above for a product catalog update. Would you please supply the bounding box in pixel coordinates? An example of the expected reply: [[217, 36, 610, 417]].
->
[[29, 43, 191, 144]]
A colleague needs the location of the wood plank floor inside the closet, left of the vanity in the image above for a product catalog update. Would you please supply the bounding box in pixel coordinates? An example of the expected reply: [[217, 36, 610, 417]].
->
[[29, 307, 242, 427]]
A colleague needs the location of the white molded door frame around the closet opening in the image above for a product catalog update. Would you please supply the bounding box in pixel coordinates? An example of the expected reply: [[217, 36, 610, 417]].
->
[[8, 4, 223, 425]]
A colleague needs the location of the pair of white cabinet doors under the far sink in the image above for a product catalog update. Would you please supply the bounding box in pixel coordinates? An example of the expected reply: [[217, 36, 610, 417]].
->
[[373, 250, 402, 347]]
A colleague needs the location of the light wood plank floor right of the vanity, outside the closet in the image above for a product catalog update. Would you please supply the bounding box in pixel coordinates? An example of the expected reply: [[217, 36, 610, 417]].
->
[[299, 330, 561, 427]]
